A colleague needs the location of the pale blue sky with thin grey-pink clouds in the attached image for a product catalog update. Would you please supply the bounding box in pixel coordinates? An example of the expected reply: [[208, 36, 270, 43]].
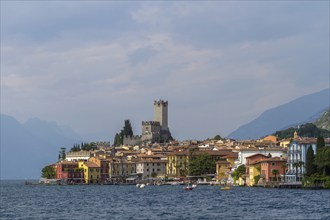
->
[[1, 1, 329, 142]]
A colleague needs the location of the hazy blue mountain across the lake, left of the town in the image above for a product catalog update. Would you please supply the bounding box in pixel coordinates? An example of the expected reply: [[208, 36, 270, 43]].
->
[[0, 114, 81, 179]]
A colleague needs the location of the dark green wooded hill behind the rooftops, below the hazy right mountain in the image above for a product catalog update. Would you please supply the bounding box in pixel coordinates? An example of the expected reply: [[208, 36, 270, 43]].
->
[[273, 123, 330, 139]]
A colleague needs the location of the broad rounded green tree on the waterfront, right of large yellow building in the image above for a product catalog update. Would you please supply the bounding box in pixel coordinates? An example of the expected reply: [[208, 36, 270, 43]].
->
[[189, 153, 216, 176]]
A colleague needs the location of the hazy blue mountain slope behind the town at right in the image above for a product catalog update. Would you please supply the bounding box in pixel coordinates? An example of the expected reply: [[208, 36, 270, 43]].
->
[[228, 88, 330, 140]]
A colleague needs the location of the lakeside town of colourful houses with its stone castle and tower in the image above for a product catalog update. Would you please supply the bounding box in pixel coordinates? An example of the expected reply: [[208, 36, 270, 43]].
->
[[40, 100, 330, 188]]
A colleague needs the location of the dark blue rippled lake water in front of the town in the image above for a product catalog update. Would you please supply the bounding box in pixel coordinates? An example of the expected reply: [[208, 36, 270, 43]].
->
[[0, 181, 330, 220]]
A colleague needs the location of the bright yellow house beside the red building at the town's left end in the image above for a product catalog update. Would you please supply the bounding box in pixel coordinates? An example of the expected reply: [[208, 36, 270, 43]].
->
[[79, 161, 101, 184]]
